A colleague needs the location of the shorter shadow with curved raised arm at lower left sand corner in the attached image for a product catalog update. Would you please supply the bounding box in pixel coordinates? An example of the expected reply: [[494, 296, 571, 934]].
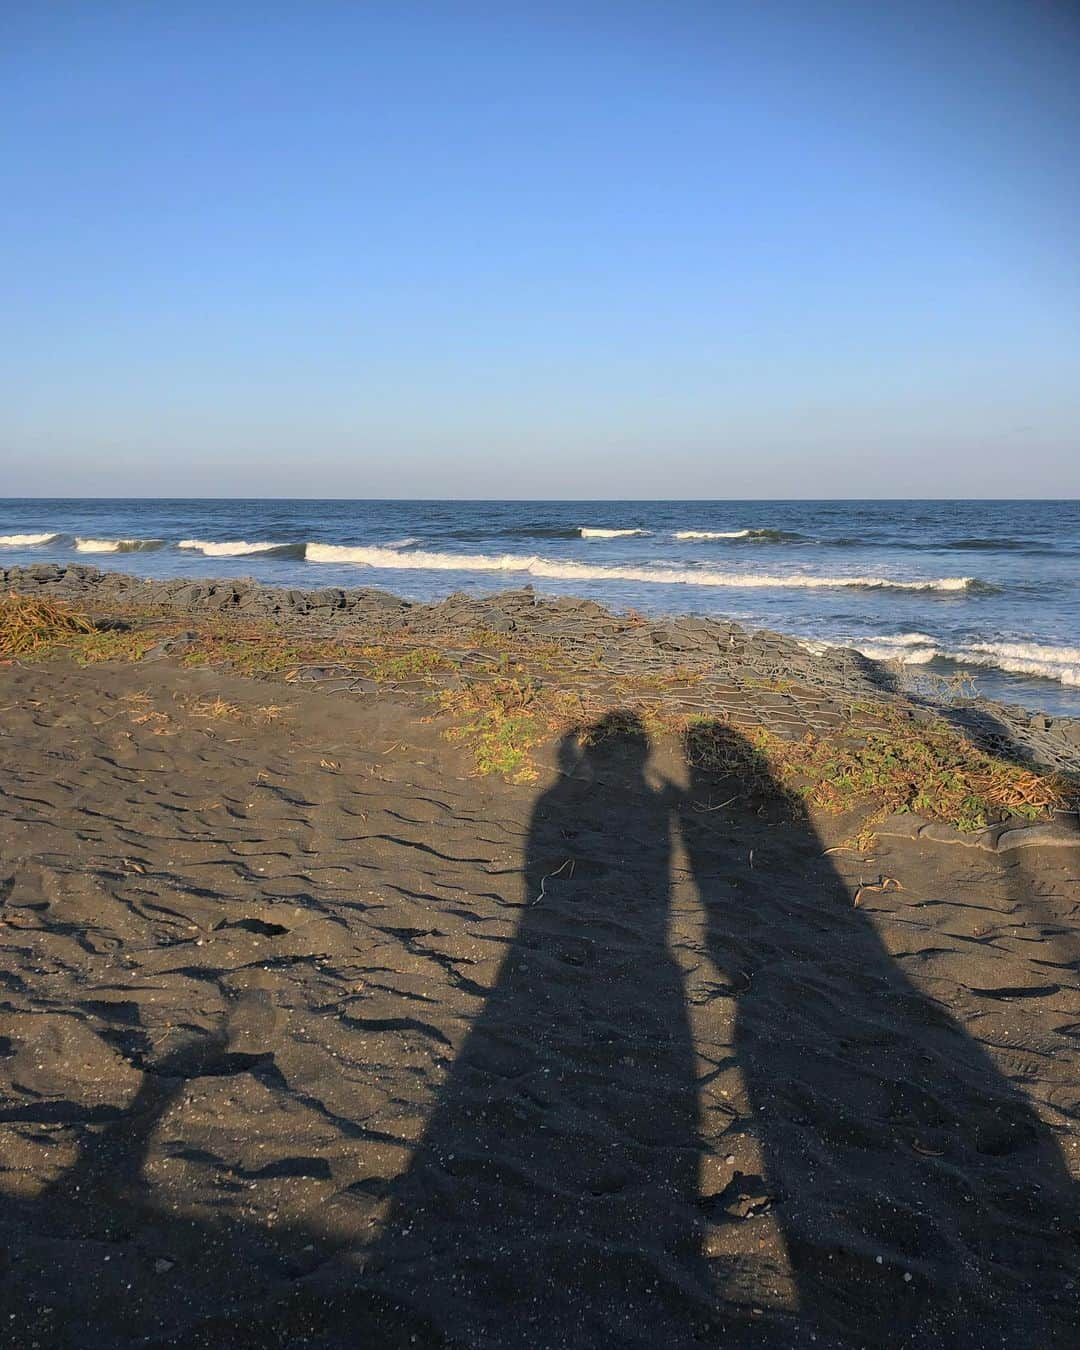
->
[[0, 990, 315, 1350]]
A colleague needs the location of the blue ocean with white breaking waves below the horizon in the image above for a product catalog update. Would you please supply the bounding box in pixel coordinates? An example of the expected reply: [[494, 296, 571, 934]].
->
[[0, 498, 1080, 716]]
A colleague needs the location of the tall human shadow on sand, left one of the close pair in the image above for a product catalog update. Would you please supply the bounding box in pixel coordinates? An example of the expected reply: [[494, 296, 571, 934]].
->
[[351, 714, 739, 1346]]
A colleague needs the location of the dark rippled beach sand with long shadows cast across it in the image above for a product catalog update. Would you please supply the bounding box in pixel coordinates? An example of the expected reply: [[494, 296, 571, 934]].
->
[[0, 664, 1080, 1350]]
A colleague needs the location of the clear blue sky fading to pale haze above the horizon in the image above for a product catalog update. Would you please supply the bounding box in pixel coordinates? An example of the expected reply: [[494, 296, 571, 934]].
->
[[0, 0, 1080, 498]]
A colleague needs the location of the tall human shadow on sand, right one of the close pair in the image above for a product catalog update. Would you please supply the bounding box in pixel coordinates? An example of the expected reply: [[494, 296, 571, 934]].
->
[[682, 724, 1080, 1347]]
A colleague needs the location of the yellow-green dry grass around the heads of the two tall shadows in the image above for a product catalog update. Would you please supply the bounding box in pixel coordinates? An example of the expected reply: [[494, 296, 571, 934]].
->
[[423, 675, 1080, 837]]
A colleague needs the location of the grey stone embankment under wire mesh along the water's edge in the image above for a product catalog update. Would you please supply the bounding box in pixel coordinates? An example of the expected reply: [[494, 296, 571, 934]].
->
[[8, 563, 1080, 774]]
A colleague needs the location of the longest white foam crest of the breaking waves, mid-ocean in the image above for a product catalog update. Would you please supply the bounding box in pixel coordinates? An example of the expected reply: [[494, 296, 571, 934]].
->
[[306, 544, 973, 591]]
